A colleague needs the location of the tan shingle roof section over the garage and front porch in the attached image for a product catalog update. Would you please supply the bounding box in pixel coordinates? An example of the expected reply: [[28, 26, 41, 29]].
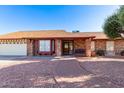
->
[[0, 30, 95, 39]]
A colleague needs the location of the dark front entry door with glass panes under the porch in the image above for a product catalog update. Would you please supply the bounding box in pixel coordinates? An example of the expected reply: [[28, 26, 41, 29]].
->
[[63, 40, 73, 55]]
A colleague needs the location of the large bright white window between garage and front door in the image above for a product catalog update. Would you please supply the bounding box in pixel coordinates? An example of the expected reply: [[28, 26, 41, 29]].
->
[[40, 40, 50, 52]]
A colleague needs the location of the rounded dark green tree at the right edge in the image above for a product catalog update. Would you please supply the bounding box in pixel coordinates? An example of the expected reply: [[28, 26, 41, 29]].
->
[[103, 5, 124, 39]]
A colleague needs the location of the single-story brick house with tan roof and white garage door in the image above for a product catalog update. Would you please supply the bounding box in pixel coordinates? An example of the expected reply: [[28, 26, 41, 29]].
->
[[0, 30, 124, 57]]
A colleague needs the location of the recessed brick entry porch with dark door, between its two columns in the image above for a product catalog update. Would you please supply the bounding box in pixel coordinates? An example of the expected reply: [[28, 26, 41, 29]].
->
[[55, 37, 92, 57]]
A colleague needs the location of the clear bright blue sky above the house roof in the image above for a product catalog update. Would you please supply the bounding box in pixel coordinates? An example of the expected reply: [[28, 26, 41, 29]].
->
[[0, 5, 119, 34]]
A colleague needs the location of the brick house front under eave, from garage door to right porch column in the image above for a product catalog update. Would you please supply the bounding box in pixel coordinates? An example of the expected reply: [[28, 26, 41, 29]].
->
[[27, 37, 93, 57]]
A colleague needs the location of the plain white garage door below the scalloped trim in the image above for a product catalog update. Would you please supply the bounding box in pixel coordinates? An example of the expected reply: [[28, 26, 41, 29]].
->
[[0, 44, 27, 56]]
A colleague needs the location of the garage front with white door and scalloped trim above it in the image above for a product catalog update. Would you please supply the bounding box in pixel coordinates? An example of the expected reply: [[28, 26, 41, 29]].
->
[[0, 39, 27, 56]]
